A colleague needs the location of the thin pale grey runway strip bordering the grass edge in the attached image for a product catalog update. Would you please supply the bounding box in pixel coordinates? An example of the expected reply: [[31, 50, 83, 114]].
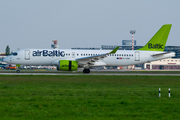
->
[[0, 73, 180, 76]]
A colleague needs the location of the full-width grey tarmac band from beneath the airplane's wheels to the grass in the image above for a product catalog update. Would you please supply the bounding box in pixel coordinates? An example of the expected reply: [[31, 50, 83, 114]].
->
[[0, 70, 180, 76]]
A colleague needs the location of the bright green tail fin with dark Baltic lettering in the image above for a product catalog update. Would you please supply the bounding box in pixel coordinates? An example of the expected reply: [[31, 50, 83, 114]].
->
[[138, 24, 172, 51]]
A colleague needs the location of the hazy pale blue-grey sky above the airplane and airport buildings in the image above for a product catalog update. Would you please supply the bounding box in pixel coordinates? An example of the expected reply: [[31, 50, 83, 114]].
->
[[0, 0, 180, 52]]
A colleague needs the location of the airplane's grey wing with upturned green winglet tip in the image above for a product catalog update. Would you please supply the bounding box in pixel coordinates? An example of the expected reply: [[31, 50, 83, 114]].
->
[[76, 46, 119, 66]]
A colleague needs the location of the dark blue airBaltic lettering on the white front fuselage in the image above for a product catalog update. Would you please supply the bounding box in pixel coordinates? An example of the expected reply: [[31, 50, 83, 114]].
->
[[32, 50, 65, 57]]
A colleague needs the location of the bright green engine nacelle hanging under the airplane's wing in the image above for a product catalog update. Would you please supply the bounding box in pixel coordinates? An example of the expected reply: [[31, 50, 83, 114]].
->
[[57, 60, 78, 71]]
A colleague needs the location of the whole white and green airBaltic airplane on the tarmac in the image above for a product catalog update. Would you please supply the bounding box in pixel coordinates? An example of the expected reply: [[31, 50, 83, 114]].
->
[[3, 24, 175, 73]]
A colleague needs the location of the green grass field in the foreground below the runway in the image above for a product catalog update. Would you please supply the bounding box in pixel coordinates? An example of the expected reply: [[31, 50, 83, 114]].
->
[[0, 75, 180, 120]]
